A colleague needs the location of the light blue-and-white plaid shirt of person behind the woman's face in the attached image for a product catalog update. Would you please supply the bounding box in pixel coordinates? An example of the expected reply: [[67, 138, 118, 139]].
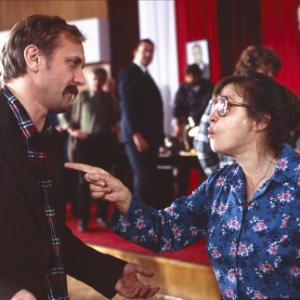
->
[[194, 102, 233, 176]]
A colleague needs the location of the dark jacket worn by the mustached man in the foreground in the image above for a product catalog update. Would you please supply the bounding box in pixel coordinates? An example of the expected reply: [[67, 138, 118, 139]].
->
[[0, 93, 124, 300]]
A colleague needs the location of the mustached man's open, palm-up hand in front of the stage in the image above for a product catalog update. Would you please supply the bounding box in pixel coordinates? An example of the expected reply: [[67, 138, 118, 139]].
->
[[115, 263, 159, 298]]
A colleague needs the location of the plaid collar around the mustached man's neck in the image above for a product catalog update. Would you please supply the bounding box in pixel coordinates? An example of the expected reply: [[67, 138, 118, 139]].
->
[[2, 86, 54, 141]]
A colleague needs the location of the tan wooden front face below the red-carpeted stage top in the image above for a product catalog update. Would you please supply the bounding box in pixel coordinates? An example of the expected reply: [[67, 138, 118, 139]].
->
[[68, 246, 220, 300]]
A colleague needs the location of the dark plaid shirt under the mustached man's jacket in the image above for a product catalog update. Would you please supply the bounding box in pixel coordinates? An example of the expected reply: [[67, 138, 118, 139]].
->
[[3, 87, 69, 300]]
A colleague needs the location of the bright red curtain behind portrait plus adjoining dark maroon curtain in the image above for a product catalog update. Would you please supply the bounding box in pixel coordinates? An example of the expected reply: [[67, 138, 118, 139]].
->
[[175, 0, 261, 83]]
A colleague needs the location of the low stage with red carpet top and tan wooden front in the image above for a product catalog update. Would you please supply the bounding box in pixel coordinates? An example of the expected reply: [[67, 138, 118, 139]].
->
[[67, 209, 220, 300]]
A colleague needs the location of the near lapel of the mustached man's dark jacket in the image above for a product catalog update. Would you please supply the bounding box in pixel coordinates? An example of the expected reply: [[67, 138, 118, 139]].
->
[[0, 94, 49, 236]]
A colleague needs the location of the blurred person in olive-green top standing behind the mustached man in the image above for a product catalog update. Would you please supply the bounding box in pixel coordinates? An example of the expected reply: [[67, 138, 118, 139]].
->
[[68, 68, 120, 232]]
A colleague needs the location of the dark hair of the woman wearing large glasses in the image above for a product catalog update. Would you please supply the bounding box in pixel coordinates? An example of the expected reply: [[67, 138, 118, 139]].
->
[[213, 73, 300, 155]]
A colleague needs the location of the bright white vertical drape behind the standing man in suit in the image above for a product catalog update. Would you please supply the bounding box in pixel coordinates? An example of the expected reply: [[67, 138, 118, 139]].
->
[[138, 0, 179, 134]]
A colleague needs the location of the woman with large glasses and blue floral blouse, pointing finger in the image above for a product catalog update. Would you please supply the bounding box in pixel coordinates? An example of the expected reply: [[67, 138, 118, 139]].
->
[[69, 73, 300, 299]]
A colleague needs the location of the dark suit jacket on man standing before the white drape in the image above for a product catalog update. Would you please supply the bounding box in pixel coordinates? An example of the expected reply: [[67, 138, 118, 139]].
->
[[118, 63, 164, 147]]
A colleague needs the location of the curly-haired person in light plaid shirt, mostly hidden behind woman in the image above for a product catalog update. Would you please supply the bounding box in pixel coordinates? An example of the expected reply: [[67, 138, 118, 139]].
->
[[194, 46, 281, 176]]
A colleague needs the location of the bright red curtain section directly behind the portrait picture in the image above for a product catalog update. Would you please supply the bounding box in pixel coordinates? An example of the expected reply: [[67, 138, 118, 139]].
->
[[175, 0, 220, 82]]
